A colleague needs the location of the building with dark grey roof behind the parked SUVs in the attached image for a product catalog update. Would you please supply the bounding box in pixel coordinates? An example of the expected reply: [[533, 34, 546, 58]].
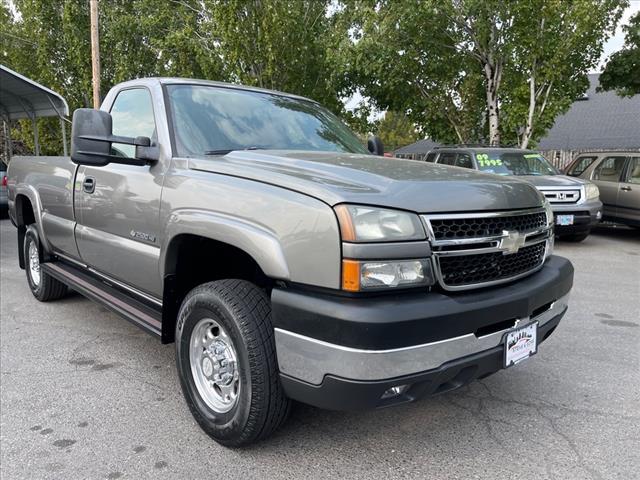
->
[[395, 74, 640, 168]]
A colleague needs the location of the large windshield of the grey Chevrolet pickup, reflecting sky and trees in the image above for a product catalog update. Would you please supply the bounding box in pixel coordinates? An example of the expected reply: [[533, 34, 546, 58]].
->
[[167, 85, 369, 157]]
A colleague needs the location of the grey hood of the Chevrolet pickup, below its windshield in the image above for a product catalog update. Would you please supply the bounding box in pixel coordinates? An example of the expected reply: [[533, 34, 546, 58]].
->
[[186, 150, 543, 213]]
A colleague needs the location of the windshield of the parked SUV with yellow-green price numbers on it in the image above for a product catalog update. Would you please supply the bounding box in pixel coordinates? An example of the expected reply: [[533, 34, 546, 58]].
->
[[476, 150, 558, 175]]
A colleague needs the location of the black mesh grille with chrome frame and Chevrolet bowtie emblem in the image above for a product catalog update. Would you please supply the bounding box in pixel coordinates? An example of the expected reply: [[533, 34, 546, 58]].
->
[[422, 209, 553, 290]]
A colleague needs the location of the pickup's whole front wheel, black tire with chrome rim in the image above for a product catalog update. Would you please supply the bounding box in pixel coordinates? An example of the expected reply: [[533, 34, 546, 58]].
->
[[176, 280, 290, 447]]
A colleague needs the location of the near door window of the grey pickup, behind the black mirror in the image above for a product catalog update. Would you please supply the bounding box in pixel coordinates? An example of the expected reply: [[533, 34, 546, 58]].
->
[[111, 88, 156, 158]]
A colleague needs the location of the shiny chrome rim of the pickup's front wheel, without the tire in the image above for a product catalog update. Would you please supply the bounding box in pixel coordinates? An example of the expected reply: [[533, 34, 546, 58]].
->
[[189, 318, 241, 413]]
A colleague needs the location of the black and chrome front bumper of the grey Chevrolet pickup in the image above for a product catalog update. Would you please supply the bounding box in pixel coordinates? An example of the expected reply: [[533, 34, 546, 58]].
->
[[272, 257, 573, 410]]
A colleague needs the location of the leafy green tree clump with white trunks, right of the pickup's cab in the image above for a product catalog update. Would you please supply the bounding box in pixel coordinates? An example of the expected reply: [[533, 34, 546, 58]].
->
[[345, 0, 627, 146]]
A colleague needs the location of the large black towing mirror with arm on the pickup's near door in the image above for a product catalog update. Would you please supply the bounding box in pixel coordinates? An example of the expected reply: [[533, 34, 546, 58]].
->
[[71, 108, 159, 167]]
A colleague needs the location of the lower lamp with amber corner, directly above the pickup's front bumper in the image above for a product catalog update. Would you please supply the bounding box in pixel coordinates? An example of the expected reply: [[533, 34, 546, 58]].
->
[[342, 259, 435, 292]]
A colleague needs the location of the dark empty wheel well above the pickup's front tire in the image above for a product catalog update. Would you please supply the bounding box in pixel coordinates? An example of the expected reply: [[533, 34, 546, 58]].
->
[[162, 234, 273, 343]]
